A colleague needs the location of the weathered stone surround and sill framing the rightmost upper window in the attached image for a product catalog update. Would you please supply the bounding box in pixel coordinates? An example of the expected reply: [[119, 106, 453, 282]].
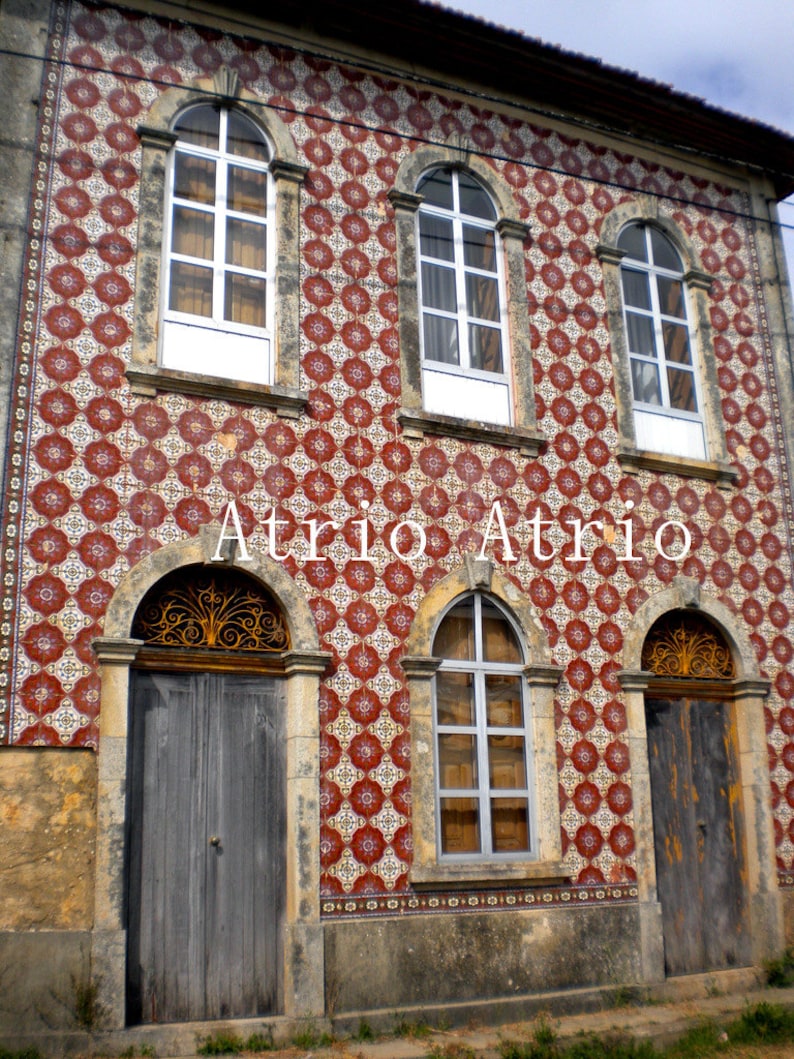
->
[[596, 196, 738, 488]]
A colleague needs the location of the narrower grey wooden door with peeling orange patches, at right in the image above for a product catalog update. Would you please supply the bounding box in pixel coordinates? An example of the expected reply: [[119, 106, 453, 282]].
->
[[646, 698, 751, 974]]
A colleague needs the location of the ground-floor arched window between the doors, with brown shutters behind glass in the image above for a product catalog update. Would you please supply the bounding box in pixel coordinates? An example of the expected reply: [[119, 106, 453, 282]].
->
[[433, 592, 537, 860]]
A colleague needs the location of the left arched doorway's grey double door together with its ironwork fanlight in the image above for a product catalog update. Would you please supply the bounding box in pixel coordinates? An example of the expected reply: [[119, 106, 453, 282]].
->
[[125, 566, 290, 1022]]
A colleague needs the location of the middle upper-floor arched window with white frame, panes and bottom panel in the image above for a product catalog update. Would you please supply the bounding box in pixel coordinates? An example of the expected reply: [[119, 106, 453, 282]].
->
[[416, 167, 512, 426]]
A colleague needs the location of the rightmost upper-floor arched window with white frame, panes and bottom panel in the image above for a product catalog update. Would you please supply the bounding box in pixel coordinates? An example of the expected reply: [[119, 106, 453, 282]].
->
[[617, 221, 706, 460]]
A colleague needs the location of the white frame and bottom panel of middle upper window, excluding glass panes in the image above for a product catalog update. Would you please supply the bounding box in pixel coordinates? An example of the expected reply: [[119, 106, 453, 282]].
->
[[416, 166, 513, 426]]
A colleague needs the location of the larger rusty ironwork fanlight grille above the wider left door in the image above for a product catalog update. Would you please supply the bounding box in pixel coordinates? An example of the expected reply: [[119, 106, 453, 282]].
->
[[132, 567, 289, 652]]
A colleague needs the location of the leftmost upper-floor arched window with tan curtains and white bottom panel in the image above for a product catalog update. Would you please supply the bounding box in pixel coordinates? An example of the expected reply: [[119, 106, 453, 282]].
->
[[161, 105, 275, 383]]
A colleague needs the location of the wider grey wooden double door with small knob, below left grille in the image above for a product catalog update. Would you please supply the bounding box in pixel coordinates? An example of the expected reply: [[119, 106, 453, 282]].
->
[[127, 671, 285, 1022]]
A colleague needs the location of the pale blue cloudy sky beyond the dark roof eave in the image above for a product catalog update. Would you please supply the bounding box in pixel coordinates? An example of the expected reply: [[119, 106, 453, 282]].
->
[[444, 0, 794, 264]]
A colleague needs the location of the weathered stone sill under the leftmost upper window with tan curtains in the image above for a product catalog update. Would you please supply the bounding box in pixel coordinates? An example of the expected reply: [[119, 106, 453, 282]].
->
[[127, 364, 308, 419]]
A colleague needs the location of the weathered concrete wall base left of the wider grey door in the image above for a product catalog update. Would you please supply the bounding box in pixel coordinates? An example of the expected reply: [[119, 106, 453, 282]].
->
[[0, 931, 91, 1040]]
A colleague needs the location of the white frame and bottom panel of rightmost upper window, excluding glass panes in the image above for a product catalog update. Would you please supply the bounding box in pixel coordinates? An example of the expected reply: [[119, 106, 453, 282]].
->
[[618, 221, 707, 460]]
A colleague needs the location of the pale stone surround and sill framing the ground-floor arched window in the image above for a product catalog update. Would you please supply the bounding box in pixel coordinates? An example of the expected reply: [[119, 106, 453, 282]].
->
[[400, 556, 571, 886]]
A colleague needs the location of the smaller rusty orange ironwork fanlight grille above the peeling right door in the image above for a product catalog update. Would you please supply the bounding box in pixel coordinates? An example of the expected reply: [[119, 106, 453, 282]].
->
[[642, 612, 736, 680]]
